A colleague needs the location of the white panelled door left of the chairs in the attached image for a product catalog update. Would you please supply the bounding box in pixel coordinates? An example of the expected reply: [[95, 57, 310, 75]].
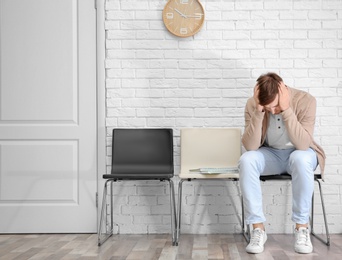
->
[[0, 0, 97, 233]]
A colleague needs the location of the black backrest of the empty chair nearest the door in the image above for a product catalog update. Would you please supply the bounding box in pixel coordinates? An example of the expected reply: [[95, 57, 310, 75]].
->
[[111, 128, 174, 178]]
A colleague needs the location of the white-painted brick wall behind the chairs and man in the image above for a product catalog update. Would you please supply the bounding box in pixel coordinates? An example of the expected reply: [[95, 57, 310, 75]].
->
[[105, 0, 342, 233]]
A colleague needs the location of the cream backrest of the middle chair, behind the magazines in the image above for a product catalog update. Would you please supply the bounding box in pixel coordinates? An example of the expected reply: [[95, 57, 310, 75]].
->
[[180, 128, 241, 174]]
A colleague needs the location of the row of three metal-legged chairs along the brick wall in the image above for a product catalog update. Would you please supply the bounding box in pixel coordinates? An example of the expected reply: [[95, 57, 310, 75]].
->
[[98, 128, 330, 246]]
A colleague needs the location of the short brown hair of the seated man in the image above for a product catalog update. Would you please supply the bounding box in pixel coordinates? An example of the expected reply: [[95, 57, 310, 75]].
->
[[257, 72, 283, 106]]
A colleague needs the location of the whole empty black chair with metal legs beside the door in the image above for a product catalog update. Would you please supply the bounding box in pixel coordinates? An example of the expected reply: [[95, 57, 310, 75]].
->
[[98, 128, 177, 246]]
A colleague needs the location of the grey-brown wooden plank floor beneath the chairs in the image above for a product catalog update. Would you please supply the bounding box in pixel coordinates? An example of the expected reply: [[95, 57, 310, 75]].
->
[[0, 234, 342, 260]]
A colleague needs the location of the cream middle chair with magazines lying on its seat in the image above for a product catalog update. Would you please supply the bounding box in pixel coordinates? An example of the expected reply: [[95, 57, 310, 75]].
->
[[176, 128, 241, 245]]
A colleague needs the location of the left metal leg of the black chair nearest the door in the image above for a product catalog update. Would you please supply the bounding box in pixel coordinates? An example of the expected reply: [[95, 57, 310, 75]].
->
[[97, 180, 114, 246]]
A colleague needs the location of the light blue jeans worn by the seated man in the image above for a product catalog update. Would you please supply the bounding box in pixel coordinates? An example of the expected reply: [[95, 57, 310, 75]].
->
[[239, 147, 318, 224]]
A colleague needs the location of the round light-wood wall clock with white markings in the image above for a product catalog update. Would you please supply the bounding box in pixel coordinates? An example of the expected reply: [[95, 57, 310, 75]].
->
[[163, 0, 204, 37]]
